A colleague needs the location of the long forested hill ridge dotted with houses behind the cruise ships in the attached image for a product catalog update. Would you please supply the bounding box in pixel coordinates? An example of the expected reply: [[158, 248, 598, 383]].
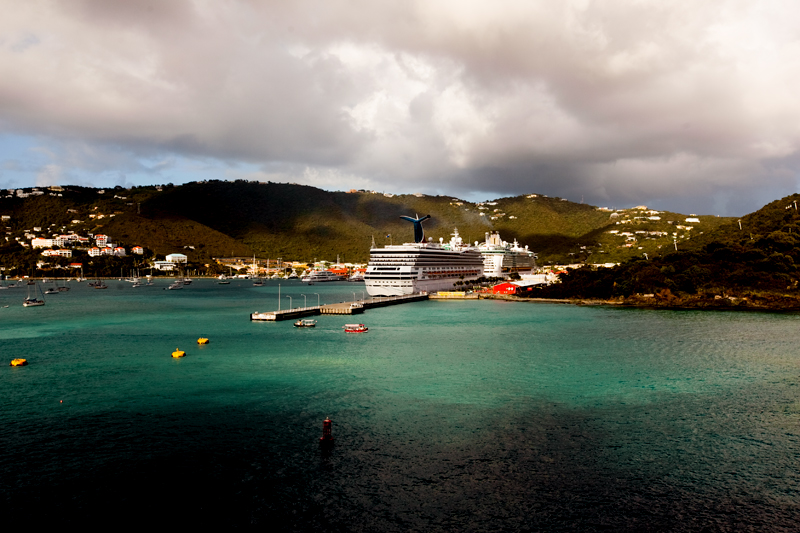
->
[[0, 181, 733, 263]]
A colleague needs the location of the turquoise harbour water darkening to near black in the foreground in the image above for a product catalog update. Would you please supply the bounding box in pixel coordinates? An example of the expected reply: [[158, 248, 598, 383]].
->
[[0, 280, 800, 531]]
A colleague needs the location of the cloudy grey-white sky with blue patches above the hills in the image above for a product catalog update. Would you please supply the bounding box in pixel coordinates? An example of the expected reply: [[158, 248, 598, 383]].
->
[[0, 0, 800, 216]]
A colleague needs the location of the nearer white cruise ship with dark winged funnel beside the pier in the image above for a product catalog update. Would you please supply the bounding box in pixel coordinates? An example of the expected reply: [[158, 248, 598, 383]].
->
[[364, 215, 483, 296]]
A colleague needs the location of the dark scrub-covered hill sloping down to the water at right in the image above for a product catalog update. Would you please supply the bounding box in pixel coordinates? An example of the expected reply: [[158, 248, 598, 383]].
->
[[537, 194, 800, 309]]
